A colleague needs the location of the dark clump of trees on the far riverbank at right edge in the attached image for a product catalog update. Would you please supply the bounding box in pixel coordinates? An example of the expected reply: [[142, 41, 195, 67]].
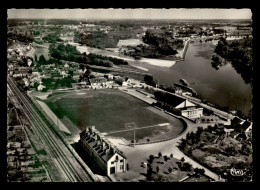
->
[[213, 38, 253, 83]]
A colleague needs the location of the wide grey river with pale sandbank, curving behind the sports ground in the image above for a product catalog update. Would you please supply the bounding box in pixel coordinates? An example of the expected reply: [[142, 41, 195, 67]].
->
[[33, 42, 252, 115]]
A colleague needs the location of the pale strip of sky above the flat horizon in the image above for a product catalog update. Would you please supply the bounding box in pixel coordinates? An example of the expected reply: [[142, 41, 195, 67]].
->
[[7, 8, 252, 20]]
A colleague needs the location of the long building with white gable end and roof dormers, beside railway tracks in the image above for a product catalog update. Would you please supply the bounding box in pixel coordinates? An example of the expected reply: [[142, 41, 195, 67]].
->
[[80, 126, 127, 175]]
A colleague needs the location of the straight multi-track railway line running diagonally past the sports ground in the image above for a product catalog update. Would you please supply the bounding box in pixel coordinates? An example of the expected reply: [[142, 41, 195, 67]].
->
[[7, 77, 93, 182]]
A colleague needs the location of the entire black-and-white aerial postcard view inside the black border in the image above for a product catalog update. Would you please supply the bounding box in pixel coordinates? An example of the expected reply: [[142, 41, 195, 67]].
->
[[6, 8, 253, 183]]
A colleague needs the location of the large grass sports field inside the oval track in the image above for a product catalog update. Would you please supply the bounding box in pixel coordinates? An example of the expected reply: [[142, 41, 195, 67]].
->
[[45, 89, 183, 139]]
